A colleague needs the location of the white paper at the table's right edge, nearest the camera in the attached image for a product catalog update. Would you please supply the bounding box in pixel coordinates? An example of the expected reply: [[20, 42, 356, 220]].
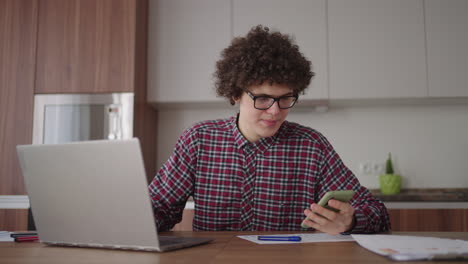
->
[[352, 235, 468, 261]]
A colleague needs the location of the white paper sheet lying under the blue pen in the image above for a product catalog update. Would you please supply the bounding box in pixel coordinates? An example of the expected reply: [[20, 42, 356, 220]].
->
[[238, 233, 354, 244]]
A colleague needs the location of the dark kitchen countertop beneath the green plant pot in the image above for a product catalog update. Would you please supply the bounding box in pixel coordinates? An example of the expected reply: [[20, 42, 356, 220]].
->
[[370, 188, 468, 202]]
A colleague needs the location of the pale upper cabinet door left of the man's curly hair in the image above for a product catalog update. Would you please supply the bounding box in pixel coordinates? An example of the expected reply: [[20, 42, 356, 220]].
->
[[148, 0, 231, 103]]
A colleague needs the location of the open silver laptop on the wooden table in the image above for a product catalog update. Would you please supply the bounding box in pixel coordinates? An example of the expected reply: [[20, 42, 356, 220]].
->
[[17, 139, 212, 252]]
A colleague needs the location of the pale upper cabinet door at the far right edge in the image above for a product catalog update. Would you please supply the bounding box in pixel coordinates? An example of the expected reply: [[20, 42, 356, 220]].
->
[[425, 0, 468, 97]]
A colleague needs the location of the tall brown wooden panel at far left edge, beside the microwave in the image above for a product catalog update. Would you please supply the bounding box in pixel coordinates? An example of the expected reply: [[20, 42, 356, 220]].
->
[[0, 0, 37, 194]]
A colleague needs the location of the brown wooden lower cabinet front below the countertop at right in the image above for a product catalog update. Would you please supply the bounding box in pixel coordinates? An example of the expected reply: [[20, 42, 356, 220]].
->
[[388, 209, 468, 232]]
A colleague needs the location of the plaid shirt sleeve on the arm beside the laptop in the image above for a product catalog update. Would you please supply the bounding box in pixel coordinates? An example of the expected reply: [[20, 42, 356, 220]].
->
[[148, 130, 197, 231]]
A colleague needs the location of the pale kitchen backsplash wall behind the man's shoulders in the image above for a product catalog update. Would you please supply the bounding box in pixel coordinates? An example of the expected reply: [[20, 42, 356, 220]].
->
[[157, 102, 468, 188]]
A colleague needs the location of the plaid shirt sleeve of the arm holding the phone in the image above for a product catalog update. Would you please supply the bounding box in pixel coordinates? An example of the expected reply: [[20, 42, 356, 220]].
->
[[316, 136, 391, 233]]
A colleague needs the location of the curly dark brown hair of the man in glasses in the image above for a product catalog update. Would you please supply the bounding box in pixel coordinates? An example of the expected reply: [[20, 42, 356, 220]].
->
[[213, 25, 315, 105]]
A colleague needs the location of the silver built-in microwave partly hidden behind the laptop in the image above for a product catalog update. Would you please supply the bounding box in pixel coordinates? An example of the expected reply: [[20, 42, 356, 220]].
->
[[32, 93, 134, 144]]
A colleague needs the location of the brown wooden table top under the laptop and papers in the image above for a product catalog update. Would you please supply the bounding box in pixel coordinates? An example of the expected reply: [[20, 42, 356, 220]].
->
[[0, 231, 468, 264]]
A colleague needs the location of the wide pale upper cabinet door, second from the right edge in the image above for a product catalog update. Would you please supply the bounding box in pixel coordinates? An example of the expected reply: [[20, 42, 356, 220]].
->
[[328, 0, 428, 99]]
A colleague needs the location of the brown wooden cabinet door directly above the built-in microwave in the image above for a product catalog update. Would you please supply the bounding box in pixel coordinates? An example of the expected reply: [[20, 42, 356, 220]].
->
[[35, 0, 136, 93]]
